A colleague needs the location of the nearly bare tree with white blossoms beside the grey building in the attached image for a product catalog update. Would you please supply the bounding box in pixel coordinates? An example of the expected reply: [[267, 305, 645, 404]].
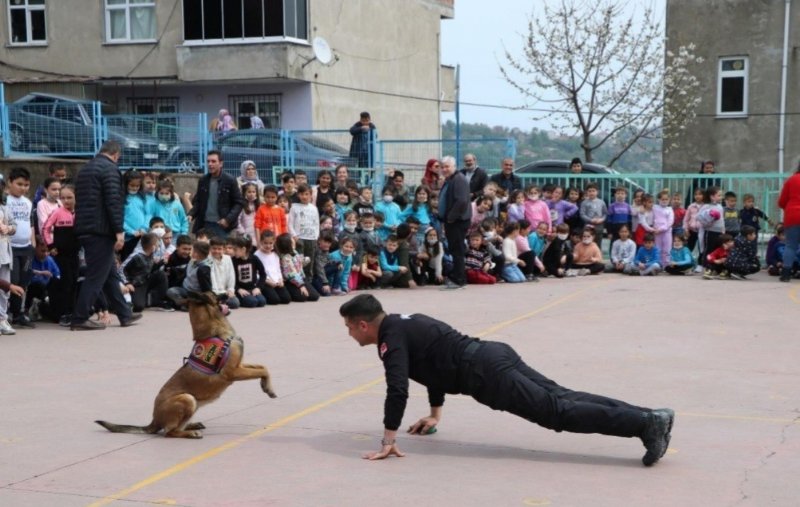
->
[[500, 0, 702, 166]]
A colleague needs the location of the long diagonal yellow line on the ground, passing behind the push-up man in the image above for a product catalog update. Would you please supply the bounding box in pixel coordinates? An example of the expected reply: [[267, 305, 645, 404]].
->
[[88, 282, 606, 507]]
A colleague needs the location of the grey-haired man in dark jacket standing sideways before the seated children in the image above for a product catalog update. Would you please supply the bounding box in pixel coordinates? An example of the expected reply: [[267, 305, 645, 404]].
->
[[438, 156, 472, 289]]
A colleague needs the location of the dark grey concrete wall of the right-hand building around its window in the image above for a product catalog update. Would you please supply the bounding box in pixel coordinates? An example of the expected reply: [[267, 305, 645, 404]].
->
[[664, 0, 800, 172]]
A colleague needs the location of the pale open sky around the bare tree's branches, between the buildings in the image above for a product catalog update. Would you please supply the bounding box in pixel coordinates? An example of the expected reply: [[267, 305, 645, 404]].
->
[[441, 0, 666, 131]]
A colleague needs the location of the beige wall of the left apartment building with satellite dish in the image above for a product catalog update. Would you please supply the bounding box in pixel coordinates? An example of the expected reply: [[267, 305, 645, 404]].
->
[[0, 0, 453, 143]]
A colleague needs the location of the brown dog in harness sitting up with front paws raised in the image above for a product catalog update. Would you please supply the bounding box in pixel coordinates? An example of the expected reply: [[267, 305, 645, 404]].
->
[[95, 292, 275, 438]]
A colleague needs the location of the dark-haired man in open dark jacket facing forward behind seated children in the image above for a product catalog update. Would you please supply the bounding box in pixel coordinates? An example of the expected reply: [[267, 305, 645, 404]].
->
[[189, 150, 244, 238]]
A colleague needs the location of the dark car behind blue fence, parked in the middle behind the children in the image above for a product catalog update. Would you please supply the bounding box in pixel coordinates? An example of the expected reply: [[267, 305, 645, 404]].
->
[[166, 129, 355, 183]]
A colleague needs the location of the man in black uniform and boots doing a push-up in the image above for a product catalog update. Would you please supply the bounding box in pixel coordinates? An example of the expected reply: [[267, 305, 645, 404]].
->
[[339, 294, 675, 466]]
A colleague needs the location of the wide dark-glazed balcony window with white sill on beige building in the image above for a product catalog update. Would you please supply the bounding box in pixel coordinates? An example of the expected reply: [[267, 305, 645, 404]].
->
[[183, 0, 308, 42]]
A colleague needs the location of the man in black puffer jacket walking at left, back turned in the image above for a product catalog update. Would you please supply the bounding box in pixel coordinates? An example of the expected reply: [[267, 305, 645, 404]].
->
[[70, 141, 142, 331]]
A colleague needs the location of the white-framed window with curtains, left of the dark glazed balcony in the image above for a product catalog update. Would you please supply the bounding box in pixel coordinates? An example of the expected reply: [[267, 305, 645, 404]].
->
[[105, 0, 156, 42]]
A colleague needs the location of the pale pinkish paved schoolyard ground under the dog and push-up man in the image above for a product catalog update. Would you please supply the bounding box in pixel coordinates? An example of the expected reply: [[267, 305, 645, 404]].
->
[[0, 274, 800, 507]]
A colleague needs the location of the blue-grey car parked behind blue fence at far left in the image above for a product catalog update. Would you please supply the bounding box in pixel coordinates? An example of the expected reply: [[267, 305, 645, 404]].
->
[[8, 93, 169, 166]]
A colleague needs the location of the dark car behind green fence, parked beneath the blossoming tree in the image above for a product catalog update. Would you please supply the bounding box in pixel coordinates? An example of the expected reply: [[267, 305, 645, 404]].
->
[[514, 160, 643, 202]]
